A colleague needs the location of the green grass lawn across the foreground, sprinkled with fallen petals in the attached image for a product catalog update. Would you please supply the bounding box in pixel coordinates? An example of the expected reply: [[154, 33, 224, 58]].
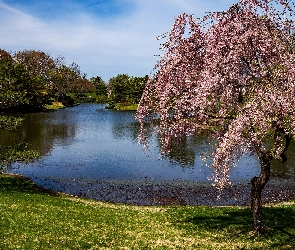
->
[[0, 174, 295, 250]]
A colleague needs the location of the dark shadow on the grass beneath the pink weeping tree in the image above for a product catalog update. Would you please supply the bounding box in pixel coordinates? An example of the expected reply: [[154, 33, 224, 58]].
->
[[175, 206, 295, 249]]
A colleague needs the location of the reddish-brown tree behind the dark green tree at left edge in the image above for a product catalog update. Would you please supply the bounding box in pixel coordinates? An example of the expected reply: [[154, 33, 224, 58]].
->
[[13, 50, 93, 106]]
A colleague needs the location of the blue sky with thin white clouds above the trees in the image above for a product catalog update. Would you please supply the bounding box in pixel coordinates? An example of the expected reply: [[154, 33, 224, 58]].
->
[[0, 0, 237, 81]]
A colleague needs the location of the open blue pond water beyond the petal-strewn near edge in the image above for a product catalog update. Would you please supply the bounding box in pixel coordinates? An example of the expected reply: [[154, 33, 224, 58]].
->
[[0, 103, 295, 197]]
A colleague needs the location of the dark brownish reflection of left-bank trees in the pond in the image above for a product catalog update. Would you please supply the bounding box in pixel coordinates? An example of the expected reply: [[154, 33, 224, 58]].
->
[[0, 112, 76, 155]]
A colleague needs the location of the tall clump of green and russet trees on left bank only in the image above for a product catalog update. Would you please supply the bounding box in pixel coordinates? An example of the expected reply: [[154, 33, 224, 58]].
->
[[0, 50, 93, 113]]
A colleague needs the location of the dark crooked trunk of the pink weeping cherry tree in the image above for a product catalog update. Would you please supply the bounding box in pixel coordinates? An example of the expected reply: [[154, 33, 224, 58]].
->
[[251, 151, 271, 235]]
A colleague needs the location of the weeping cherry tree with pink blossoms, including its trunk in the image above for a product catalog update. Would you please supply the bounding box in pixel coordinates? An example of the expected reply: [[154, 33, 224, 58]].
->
[[137, 0, 295, 234]]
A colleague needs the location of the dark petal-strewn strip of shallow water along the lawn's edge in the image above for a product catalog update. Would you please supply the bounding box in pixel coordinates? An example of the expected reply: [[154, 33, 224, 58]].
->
[[5, 173, 295, 206]]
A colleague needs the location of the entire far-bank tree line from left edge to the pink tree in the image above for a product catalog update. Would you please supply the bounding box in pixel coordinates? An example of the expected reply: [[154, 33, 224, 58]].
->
[[0, 49, 148, 113]]
